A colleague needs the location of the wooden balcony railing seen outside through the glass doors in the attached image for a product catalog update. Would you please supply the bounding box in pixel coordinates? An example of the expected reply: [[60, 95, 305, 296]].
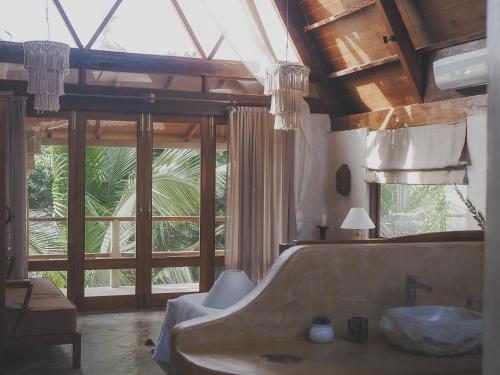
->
[[28, 216, 225, 288]]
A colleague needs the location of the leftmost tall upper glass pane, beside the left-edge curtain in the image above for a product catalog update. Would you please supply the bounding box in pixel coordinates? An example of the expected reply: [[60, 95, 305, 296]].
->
[[26, 117, 68, 259]]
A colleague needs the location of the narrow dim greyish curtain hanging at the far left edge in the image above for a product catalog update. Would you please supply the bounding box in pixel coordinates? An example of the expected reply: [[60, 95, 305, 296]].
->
[[6, 96, 28, 278]]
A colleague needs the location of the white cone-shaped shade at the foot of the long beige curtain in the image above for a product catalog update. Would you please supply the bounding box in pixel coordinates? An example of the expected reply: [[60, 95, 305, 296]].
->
[[202, 271, 253, 309]]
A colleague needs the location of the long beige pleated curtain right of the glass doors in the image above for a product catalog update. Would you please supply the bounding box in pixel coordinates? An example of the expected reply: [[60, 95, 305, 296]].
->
[[226, 107, 295, 283]]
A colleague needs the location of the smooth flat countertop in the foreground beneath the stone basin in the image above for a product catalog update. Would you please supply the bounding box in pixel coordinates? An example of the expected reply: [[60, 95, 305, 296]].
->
[[180, 337, 481, 375]]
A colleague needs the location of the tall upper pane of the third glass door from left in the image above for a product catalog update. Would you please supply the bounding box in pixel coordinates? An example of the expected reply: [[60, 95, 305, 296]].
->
[[152, 122, 201, 255]]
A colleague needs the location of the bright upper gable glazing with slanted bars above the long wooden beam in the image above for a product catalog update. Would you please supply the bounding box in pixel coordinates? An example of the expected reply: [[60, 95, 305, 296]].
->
[[0, 0, 298, 61]]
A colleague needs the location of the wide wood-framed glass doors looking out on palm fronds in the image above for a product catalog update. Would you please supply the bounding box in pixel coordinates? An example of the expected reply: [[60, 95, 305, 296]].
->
[[26, 112, 228, 309]]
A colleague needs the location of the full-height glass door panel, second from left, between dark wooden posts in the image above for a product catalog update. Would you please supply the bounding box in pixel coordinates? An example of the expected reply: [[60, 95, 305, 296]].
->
[[84, 115, 138, 306]]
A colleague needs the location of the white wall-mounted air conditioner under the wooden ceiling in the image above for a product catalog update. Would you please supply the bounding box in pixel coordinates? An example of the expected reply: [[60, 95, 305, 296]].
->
[[434, 48, 488, 90]]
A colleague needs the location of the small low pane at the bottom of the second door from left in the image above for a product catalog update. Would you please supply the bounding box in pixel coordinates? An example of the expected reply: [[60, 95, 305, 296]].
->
[[84, 268, 136, 297]]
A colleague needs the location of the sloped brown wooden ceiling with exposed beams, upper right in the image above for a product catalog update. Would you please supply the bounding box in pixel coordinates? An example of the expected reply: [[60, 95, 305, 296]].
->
[[275, 0, 486, 116]]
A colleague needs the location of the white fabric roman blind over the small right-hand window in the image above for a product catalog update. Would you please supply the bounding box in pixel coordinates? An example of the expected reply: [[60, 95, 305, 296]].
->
[[365, 122, 467, 184]]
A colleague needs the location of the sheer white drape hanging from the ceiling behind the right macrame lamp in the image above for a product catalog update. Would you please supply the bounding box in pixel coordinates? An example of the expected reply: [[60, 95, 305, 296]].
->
[[204, 0, 320, 232]]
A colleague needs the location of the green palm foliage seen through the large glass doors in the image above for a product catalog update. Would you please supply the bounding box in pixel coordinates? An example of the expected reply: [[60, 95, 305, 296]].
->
[[28, 146, 227, 287]]
